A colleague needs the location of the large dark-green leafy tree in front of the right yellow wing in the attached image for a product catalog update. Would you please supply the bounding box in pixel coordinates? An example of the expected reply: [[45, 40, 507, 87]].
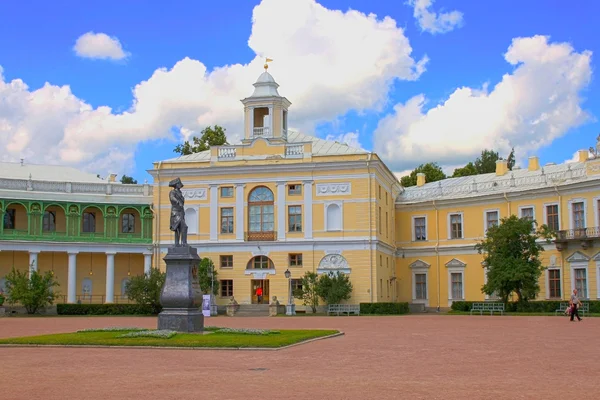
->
[[475, 215, 550, 303]]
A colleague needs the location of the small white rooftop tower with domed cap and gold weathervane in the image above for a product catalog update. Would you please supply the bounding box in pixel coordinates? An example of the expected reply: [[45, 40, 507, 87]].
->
[[241, 58, 292, 142]]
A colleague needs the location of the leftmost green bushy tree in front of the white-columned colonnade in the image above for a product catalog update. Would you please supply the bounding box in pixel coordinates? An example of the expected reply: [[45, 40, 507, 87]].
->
[[6, 267, 59, 314]]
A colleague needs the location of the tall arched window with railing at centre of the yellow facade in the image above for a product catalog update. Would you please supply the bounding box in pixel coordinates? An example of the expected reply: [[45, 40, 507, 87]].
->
[[248, 186, 275, 240]]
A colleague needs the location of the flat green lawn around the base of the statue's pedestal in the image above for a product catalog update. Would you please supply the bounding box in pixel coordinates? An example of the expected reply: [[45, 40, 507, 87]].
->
[[0, 329, 339, 348]]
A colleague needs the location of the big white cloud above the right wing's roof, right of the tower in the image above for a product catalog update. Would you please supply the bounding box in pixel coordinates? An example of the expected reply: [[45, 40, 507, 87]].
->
[[373, 36, 592, 170]]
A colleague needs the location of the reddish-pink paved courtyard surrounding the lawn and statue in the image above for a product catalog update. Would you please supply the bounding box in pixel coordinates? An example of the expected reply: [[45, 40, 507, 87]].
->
[[0, 315, 600, 400]]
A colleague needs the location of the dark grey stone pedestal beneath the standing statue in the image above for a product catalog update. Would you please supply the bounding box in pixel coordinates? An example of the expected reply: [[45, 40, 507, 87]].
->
[[158, 246, 204, 332]]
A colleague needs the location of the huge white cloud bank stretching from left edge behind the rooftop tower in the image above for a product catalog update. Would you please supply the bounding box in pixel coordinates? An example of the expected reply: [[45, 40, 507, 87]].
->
[[0, 0, 427, 173]]
